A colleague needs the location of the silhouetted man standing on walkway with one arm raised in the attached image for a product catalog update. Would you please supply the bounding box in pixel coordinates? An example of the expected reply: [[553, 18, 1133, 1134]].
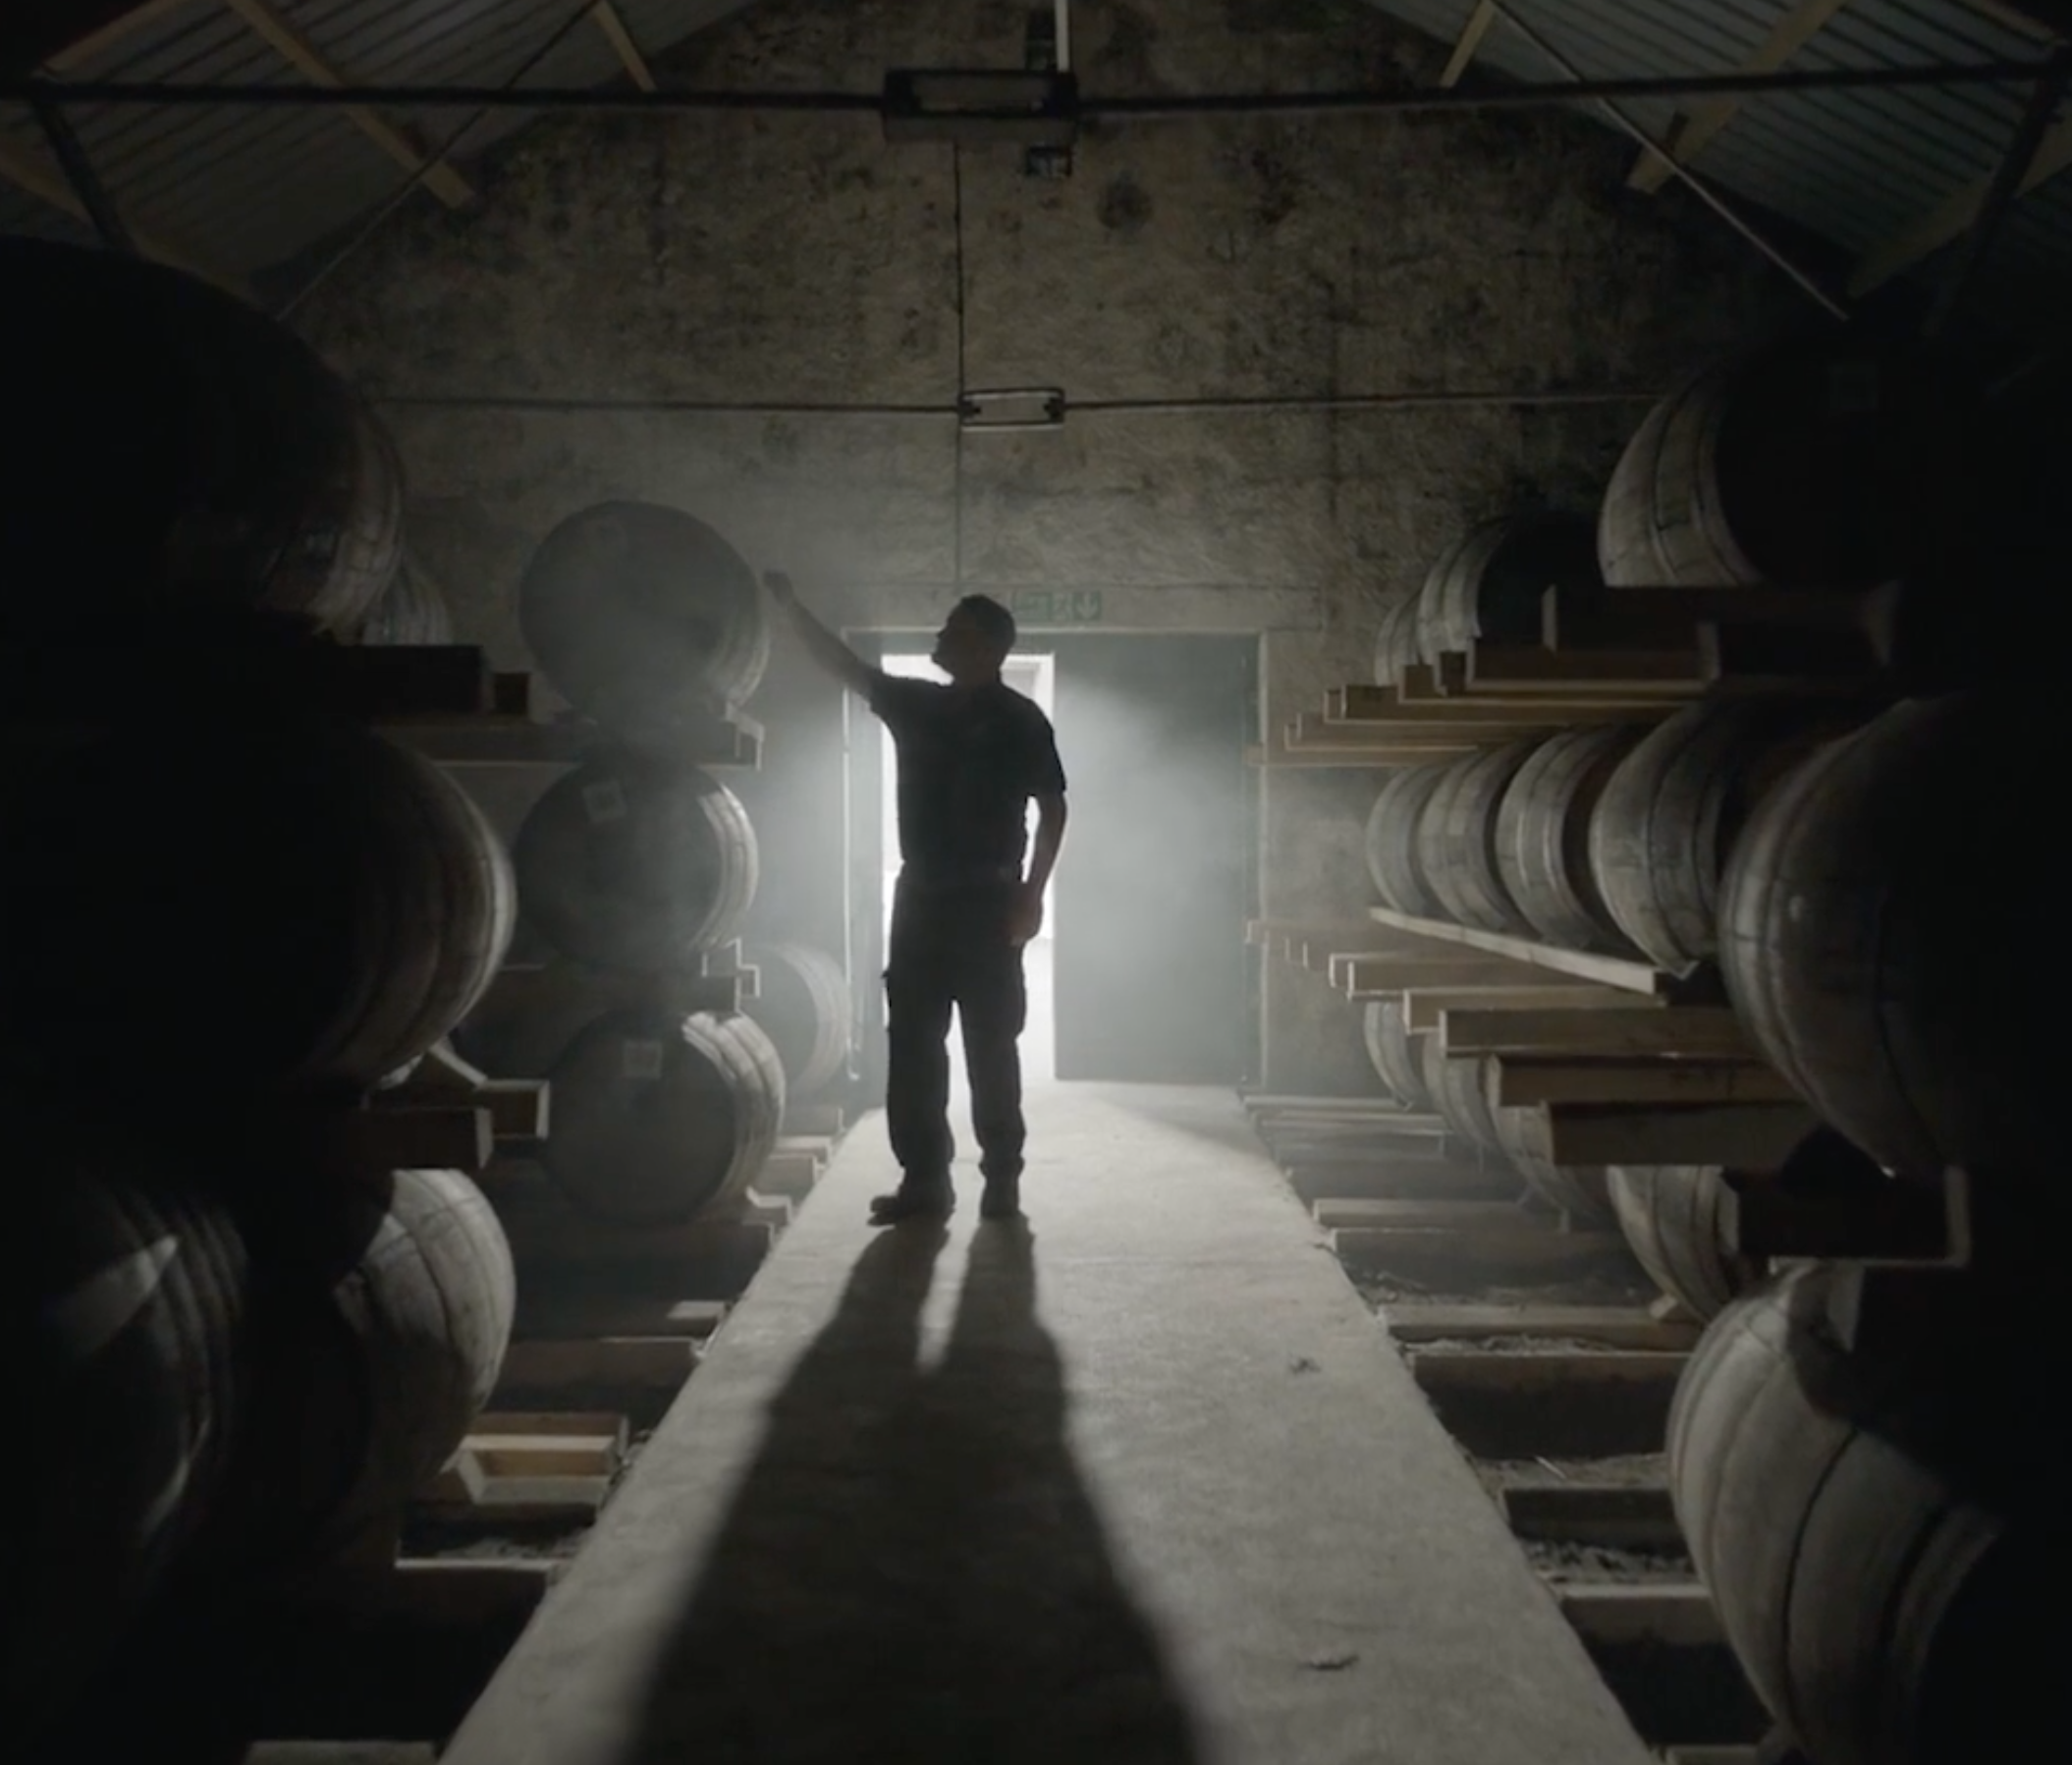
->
[[765, 574, 1065, 1227]]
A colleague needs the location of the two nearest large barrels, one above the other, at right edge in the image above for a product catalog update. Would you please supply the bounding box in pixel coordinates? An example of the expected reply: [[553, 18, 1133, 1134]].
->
[[1670, 691, 2072, 1765]]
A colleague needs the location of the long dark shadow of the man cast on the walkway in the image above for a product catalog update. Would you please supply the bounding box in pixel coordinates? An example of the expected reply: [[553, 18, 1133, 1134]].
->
[[640, 1225, 1198, 1765]]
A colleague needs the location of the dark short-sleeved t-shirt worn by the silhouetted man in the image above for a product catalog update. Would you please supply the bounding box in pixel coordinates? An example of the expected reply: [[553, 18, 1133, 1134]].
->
[[870, 676, 1065, 883]]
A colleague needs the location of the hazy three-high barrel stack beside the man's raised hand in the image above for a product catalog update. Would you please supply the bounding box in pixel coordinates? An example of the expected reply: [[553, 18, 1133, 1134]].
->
[[460, 501, 786, 1227]]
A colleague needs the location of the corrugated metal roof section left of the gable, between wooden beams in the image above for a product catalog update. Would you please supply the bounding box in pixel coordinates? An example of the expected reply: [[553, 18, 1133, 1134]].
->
[[0, 0, 762, 276]]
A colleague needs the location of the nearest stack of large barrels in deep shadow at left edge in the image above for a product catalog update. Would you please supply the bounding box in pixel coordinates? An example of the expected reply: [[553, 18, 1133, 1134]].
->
[[0, 241, 514, 1742]]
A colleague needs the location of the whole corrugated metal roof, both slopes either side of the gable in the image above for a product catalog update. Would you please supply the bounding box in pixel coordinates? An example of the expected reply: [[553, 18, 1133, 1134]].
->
[[0, 0, 2072, 350]]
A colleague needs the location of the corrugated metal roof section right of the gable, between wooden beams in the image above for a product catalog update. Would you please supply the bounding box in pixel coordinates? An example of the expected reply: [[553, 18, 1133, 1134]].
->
[[1374, 0, 2072, 344]]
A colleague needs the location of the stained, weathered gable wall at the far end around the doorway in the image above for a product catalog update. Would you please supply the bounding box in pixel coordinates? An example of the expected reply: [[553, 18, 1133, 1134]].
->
[[297, 0, 1803, 1092]]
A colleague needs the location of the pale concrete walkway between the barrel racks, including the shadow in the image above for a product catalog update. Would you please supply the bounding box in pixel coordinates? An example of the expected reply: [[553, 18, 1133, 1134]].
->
[[446, 1085, 1650, 1765]]
